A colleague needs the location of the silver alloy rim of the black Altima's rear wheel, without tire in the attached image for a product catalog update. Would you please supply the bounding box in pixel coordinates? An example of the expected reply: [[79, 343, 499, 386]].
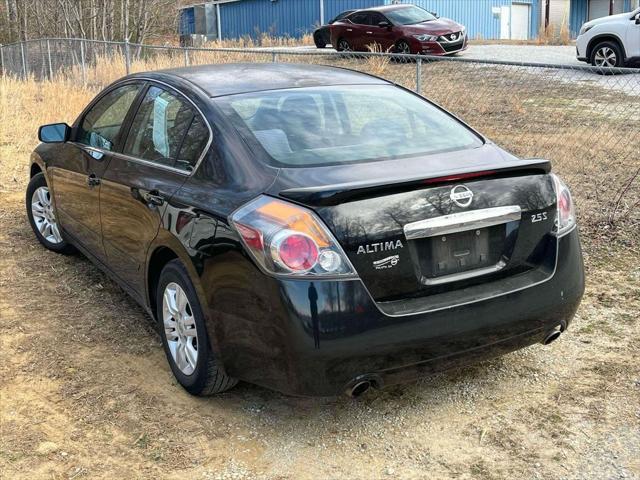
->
[[162, 282, 198, 375]]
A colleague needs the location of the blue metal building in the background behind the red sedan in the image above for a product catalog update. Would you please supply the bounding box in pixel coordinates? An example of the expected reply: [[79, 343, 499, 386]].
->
[[180, 0, 638, 40]]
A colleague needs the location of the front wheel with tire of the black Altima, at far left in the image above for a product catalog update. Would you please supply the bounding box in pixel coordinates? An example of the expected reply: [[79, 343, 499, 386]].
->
[[25, 172, 76, 254]]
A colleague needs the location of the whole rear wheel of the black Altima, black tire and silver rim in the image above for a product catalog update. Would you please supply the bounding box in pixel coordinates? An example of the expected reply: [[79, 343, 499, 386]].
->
[[156, 260, 238, 396]]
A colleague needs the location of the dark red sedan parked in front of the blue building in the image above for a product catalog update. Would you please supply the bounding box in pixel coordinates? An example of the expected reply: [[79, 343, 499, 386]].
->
[[330, 5, 468, 55]]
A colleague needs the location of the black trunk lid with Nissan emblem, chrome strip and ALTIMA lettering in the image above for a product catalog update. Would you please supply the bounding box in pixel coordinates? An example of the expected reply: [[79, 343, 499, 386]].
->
[[268, 146, 556, 302]]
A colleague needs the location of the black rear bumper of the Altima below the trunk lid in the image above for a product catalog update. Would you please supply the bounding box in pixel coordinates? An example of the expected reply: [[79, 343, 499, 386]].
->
[[217, 230, 584, 395]]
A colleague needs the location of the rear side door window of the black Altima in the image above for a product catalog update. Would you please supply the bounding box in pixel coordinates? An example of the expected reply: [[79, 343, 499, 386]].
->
[[123, 86, 209, 171]]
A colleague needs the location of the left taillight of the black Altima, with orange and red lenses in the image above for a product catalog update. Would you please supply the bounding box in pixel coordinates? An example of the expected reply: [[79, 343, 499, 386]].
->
[[229, 195, 355, 277]]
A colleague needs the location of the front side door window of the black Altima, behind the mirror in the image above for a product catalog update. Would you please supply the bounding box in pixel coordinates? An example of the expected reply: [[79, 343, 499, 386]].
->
[[76, 83, 142, 151]]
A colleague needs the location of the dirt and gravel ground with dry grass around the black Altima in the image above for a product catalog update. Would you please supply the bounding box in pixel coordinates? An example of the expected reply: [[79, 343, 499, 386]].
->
[[0, 72, 640, 479]]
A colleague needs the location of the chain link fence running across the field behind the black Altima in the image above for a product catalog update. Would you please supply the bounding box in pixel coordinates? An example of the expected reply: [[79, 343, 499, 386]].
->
[[0, 39, 640, 227]]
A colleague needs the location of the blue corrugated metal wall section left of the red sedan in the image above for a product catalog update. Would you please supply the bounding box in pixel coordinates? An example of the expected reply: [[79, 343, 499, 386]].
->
[[220, 0, 320, 38]]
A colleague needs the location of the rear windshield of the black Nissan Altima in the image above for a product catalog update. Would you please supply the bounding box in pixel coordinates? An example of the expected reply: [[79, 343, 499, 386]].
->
[[216, 85, 482, 167]]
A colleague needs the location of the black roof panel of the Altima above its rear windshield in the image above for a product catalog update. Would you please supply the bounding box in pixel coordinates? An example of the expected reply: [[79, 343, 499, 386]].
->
[[138, 63, 390, 97]]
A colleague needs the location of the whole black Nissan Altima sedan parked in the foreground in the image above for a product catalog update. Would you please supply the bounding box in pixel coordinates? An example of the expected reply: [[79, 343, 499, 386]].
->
[[26, 63, 584, 395]]
